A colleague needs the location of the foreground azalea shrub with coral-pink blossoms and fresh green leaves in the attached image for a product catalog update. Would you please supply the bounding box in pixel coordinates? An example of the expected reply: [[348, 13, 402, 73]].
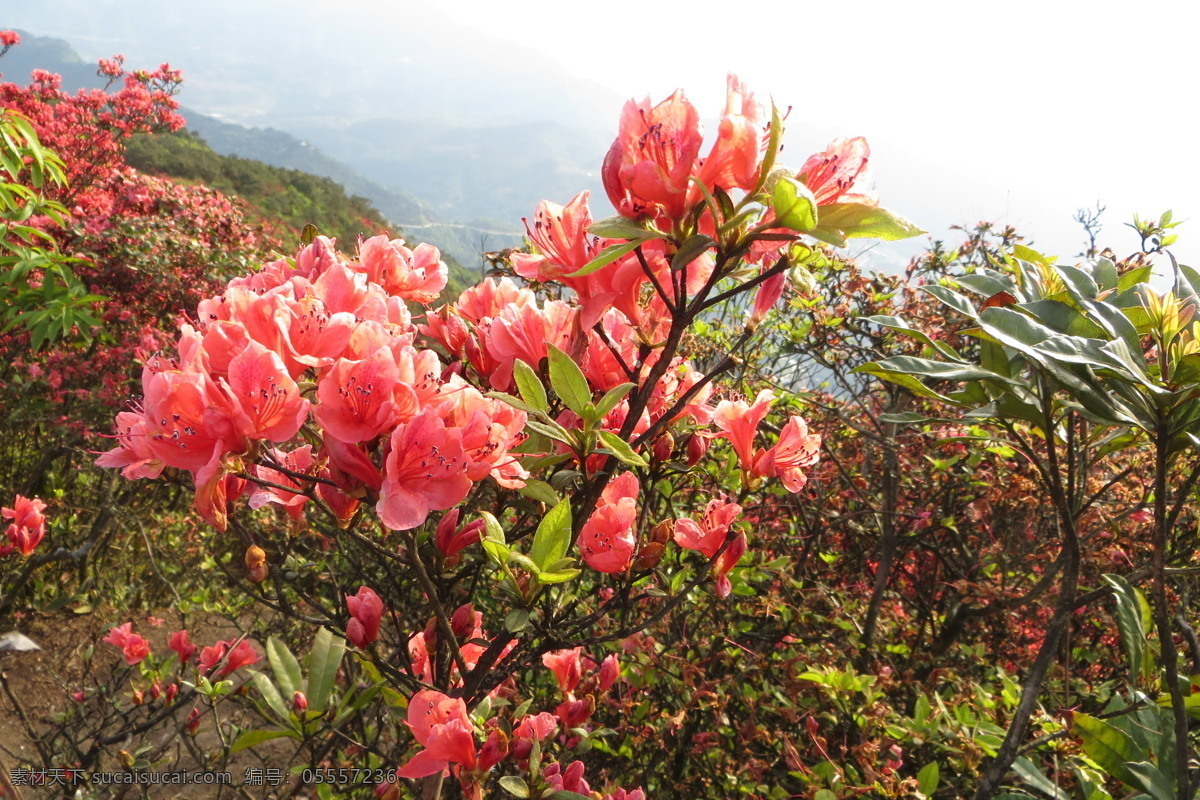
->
[[98, 71, 917, 798]]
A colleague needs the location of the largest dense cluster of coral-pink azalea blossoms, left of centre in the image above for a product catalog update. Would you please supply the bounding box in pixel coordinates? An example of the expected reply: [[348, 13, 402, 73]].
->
[[90, 236, 526, 530]]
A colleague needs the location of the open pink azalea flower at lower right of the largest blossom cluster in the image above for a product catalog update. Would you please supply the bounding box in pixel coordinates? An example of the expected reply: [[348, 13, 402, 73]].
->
[[376, 409, 472, 530]]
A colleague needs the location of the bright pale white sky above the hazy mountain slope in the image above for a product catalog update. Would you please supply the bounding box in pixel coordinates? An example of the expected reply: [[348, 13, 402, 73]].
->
[[438, 0, 1200, 264]]
